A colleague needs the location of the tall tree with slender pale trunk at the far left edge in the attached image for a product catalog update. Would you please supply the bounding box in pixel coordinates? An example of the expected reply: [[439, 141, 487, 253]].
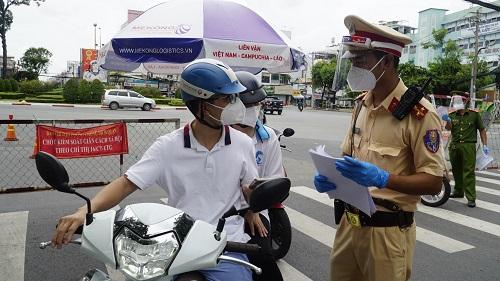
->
[[0, 0, 45, 79]]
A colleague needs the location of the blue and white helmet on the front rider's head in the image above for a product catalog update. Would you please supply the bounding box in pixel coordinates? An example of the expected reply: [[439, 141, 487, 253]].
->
[[179, 59, 246, 115]]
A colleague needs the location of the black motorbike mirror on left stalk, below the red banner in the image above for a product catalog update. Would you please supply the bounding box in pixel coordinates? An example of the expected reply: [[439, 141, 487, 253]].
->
[[35, 151, 74, 193]]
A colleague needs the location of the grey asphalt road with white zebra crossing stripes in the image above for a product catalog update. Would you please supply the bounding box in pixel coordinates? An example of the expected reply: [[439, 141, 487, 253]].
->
[[0, 105, 500, 281]]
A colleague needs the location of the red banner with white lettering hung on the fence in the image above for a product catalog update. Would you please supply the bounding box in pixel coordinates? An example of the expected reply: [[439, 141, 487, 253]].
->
[[36, 123, 128, 159]]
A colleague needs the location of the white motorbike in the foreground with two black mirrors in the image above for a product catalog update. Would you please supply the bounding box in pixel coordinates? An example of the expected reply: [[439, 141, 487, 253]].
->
[[35, 152, 290, 281]]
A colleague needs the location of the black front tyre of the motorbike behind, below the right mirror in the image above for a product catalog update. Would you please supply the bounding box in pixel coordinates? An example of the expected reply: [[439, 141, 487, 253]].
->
[[269, 208, 292, 260]]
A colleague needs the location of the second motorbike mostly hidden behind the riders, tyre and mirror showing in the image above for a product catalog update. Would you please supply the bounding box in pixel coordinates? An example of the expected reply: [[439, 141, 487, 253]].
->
[[269, 128, 295, 260]]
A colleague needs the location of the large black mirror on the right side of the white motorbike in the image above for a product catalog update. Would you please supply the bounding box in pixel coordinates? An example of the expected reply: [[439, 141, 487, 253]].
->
[[250, 178, 291, 212]]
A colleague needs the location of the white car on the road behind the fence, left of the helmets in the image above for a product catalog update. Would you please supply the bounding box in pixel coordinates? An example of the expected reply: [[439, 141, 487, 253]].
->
[[102, 89, 156, 111]]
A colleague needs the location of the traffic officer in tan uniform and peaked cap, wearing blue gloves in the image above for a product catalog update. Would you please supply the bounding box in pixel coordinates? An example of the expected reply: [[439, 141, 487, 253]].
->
[[314, 15, 443, 281]]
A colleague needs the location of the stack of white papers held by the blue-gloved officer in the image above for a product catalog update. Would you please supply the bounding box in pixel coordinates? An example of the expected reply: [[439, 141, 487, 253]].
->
[[309, 145, 377, 216]]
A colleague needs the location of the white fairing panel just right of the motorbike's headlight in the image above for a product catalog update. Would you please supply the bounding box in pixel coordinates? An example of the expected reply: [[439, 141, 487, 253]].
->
[[168, 220, 227, 276]]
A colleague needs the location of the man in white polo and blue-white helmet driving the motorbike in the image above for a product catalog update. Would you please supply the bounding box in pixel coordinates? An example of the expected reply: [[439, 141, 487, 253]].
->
[[52, 59, 258, 281]]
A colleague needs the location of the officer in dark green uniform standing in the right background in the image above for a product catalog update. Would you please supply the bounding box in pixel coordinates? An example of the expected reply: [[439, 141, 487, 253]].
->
[[442, 95, 489, 208]]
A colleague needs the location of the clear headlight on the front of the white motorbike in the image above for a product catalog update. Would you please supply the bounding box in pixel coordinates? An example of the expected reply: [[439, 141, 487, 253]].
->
[[115, 227, 179, 280]]
